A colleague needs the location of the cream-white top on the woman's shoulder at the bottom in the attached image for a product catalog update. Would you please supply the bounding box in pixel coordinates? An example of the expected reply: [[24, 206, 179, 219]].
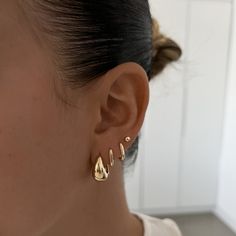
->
[[131, 211, 182, 236]]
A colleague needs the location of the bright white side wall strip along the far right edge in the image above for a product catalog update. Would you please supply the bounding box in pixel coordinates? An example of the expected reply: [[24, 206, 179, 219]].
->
[[216, 0, 236, 231]]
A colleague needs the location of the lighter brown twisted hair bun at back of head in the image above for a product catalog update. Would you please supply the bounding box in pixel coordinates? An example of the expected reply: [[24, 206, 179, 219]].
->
[[151, 18, 182, 78]]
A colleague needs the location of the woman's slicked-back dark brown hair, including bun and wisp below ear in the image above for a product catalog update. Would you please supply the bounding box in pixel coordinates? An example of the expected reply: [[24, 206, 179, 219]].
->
[[21, 0, 181, 169]]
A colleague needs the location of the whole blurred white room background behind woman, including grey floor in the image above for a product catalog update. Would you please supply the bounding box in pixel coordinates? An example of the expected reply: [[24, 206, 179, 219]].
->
[[125, 0, 236, 236]]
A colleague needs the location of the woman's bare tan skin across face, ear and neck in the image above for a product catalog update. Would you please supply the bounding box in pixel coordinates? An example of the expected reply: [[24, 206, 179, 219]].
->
[[0, 0, 149, 236]]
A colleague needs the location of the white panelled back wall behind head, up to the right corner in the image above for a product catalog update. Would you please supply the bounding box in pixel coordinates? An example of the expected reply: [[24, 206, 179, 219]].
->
[[125, 0, 232, 214]]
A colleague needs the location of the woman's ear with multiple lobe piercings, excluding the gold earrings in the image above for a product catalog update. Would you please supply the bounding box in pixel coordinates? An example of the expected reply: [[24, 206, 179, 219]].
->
[[91, 62, 149, 168]]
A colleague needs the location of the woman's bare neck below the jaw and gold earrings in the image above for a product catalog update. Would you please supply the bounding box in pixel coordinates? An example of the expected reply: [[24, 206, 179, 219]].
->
[[40, 159, 144, 236]]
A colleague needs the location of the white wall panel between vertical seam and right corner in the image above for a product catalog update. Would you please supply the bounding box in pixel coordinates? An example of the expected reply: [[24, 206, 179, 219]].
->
[[179, 0, 231, 207]]
